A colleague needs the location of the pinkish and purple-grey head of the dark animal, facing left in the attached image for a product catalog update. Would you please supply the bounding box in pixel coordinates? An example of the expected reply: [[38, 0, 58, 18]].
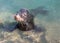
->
[[14, 8, 29, 22]]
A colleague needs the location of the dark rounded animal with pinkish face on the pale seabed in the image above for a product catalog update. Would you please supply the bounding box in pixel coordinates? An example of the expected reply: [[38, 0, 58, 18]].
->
[[14, 9, 34, 31]]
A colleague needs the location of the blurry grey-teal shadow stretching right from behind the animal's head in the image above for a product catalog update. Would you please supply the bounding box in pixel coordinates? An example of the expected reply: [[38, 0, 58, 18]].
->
[[30, 6, 49, 16]]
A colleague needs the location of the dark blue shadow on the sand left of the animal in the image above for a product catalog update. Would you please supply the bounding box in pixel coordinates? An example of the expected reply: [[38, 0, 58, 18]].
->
[[0, 22, 16, 32]]
